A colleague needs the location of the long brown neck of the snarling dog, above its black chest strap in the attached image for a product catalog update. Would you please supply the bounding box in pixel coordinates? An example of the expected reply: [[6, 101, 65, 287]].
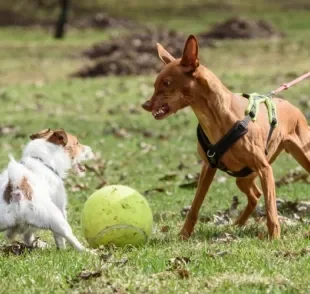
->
[[191, 66, 240, 144]]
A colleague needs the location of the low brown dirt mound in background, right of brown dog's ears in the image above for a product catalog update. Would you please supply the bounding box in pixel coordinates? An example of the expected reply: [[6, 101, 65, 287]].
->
[[200, 17, 284, 40]]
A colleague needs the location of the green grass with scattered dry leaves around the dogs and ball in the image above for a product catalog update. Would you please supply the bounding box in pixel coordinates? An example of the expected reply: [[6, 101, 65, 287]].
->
[[0, 0, 310, 293]]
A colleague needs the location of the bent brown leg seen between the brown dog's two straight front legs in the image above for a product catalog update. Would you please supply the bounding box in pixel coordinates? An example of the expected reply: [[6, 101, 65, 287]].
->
[[234, 176, 262, 226]]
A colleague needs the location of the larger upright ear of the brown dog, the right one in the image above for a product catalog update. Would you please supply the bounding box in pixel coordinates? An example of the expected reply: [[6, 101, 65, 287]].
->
[[181, 35, 199, 71]]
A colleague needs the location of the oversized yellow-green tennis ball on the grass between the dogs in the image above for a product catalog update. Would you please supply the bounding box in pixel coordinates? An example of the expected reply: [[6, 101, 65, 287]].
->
[[81, 185, 153, 248]]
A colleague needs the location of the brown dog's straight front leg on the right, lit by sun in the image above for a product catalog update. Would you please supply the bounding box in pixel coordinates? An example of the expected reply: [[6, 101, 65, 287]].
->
[[258, 165, 281, 239]]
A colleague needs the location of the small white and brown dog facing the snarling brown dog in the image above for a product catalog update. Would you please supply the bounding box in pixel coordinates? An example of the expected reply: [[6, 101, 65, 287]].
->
[[0, 129, 93, 251]]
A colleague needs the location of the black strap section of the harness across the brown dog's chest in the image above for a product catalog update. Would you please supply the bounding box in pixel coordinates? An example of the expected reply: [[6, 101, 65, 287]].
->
[[197, 115, 253, 177]]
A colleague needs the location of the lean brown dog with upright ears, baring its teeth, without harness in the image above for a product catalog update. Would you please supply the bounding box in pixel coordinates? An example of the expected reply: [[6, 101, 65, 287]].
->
[[142, 36, 310, 239]]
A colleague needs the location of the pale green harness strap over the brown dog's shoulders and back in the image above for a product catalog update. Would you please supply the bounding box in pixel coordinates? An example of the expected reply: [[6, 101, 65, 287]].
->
[[237, 93, 278, 155]]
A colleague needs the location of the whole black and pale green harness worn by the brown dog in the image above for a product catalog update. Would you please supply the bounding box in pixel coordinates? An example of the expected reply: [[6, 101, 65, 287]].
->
[[197, 93, 278, 178]]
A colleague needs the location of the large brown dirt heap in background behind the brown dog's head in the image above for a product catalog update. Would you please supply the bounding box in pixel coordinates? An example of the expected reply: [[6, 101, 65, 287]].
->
[[72, 28, 211, 78]]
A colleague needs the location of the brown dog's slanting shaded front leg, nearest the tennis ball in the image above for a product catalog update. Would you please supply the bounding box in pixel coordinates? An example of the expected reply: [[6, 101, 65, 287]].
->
[[180, 163, 217, 240]]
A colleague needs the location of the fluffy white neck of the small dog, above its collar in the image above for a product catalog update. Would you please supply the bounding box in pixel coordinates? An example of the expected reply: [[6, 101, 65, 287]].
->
[[22, 139, 71, 179]]
